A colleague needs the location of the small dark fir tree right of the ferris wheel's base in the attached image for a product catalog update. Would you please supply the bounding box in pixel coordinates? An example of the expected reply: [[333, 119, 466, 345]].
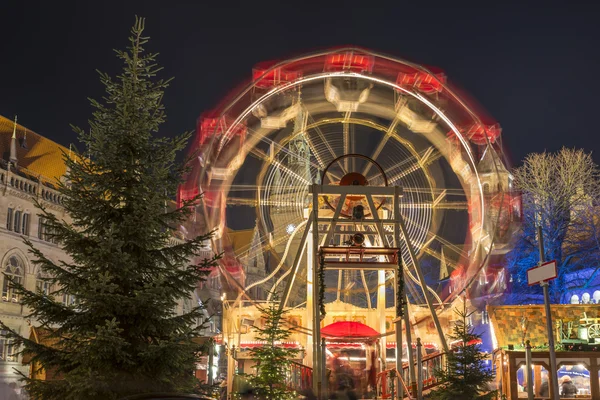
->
[[428, 304, 498, 400]]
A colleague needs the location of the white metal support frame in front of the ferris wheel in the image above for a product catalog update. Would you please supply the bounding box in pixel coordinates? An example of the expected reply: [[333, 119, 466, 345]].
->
[[280, 184, 448, 395]]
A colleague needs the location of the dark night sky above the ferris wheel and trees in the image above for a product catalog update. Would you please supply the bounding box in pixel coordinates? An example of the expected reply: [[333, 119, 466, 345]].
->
[[0, 0, 600, 164]]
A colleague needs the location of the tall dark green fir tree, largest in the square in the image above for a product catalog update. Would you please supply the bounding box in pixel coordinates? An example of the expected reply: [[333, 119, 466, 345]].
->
[[3, 19, 214, 400]]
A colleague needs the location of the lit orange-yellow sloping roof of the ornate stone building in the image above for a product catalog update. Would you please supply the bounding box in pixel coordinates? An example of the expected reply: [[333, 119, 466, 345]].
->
[[0, 115, 69, 180]]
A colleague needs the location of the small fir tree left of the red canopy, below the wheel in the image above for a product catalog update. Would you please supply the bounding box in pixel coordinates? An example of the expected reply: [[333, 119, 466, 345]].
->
[[245, 299, 299, 400]]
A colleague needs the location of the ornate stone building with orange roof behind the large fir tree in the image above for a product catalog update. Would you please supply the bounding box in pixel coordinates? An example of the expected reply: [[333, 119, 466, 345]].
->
[[0, 116, 216, 386]]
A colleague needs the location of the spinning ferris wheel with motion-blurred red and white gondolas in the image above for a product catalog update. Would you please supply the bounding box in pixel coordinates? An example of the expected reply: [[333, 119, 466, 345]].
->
[[179, 48, 514, 342]]
